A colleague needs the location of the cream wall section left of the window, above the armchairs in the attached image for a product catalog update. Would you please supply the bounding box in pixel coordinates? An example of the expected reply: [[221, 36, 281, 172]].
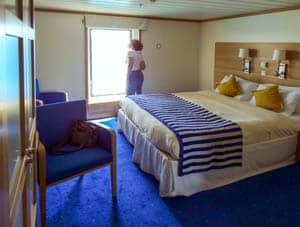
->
[[35, 13, 85, 99]]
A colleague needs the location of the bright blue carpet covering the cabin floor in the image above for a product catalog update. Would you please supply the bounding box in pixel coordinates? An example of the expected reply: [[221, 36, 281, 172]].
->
[[47, 119, 300, 227]]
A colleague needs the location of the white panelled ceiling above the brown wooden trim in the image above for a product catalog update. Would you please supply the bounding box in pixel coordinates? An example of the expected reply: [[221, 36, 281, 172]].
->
[[35, 0, 300, 20]]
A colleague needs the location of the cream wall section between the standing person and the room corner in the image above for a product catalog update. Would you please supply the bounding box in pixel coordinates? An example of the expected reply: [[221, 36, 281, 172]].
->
[[142, 21, 199, 92]]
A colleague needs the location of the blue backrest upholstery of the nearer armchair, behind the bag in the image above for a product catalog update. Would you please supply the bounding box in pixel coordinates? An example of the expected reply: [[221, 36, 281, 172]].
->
[[36, 100, 86, 150]]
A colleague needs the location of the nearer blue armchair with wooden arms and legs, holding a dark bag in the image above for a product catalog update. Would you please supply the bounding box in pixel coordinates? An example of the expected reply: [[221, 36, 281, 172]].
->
[[36, 100, 116, 226]]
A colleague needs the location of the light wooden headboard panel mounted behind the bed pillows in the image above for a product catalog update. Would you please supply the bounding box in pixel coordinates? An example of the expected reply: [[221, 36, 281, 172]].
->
[[214, 43, 300, 87]]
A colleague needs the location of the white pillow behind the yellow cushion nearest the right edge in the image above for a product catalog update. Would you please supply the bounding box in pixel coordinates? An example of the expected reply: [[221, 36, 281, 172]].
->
[[250, 84, 300, 116]]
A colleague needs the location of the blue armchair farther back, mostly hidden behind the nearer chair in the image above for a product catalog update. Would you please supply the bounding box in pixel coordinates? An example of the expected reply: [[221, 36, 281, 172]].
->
[[35, 79, 68, 106]]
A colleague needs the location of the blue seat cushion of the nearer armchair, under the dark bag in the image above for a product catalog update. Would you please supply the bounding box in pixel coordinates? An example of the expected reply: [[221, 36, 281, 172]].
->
[[47, 147, 112, 184]]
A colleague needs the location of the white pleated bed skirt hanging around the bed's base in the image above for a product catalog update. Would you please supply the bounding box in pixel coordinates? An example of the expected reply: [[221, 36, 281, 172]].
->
[[118, 110, 297, 197]]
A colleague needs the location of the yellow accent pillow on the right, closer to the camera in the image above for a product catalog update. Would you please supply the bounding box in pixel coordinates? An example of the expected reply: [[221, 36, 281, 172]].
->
[[253, 86, 284, 112]]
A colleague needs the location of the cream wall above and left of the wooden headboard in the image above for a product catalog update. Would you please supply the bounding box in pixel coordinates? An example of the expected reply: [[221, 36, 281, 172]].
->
[[199, 10, 300, 89]]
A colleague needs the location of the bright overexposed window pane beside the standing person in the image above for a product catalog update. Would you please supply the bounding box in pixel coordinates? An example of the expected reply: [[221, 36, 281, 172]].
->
[[90, 29, 130, 100]]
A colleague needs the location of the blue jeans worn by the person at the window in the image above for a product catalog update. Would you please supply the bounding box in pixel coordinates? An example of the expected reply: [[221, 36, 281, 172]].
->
[[126, 70, 144, 95]]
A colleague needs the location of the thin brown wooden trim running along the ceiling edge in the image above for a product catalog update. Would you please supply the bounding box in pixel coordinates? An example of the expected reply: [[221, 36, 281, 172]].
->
[[34, 5, 300, 23]]
